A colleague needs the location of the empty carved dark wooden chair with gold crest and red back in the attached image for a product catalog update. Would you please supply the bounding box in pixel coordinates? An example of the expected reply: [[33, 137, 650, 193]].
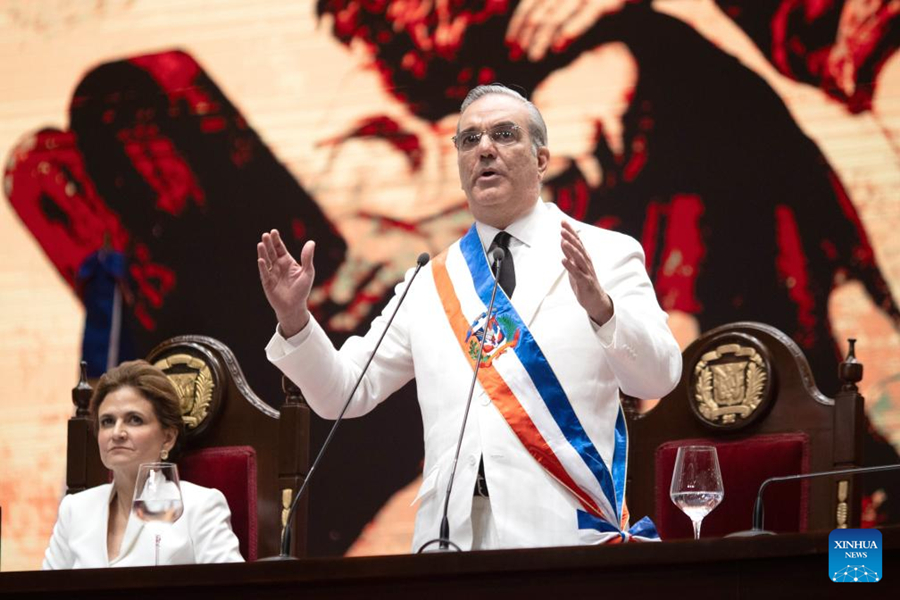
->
[[623, 322, 865, 539]]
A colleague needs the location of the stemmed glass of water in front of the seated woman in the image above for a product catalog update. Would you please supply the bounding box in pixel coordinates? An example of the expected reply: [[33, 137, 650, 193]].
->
[[132, 462, 184, 566]]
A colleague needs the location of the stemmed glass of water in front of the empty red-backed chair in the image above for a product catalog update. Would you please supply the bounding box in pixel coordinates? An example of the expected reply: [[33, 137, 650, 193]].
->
[[669, 446, 725, 540]]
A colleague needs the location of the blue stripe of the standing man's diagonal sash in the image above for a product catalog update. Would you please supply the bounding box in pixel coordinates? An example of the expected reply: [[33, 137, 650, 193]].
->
[[460, 225, 628, 531]]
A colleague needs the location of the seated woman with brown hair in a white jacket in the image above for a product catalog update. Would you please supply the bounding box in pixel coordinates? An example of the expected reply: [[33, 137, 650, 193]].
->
[[43, 360, 244, 569]]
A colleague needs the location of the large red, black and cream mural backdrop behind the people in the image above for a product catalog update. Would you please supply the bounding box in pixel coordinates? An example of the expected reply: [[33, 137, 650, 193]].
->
[[0, 0, 900, 569]]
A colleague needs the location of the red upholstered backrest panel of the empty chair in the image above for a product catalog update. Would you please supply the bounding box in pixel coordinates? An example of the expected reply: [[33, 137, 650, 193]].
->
[[655, 432, 809, 540]]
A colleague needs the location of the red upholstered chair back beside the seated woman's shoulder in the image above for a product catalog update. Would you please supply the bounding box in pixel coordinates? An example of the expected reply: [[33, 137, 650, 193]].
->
[[178, 446, 258, 561]]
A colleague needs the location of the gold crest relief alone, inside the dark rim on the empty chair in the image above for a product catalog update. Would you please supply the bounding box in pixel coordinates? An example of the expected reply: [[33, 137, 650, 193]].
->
[[694, 343, 769, 426]]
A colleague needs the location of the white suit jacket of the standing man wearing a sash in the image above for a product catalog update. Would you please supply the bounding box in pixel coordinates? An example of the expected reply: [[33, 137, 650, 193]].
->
[[266, 202, 681, 550]]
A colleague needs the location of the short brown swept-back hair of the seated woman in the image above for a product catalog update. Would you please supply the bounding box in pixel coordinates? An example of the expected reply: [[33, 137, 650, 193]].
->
[[88, 360, 184, 460]]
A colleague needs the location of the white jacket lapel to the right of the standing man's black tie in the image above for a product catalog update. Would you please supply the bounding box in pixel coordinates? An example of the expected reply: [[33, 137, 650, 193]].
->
[[512, 204, 565, 326]]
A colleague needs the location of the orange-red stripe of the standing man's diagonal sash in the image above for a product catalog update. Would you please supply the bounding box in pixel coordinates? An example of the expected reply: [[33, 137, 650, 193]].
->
[[431, 251, 602, 518]]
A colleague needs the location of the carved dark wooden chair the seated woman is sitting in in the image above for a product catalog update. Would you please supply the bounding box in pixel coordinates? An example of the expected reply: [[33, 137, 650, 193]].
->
[[66, 335, 309, 561]]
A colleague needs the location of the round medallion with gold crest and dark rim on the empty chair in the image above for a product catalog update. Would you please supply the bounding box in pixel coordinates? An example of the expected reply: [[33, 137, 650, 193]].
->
[[690, 334, 772, 429]]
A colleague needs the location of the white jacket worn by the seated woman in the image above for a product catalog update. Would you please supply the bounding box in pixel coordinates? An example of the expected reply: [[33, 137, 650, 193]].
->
[[43, 481, 244, 570]]
